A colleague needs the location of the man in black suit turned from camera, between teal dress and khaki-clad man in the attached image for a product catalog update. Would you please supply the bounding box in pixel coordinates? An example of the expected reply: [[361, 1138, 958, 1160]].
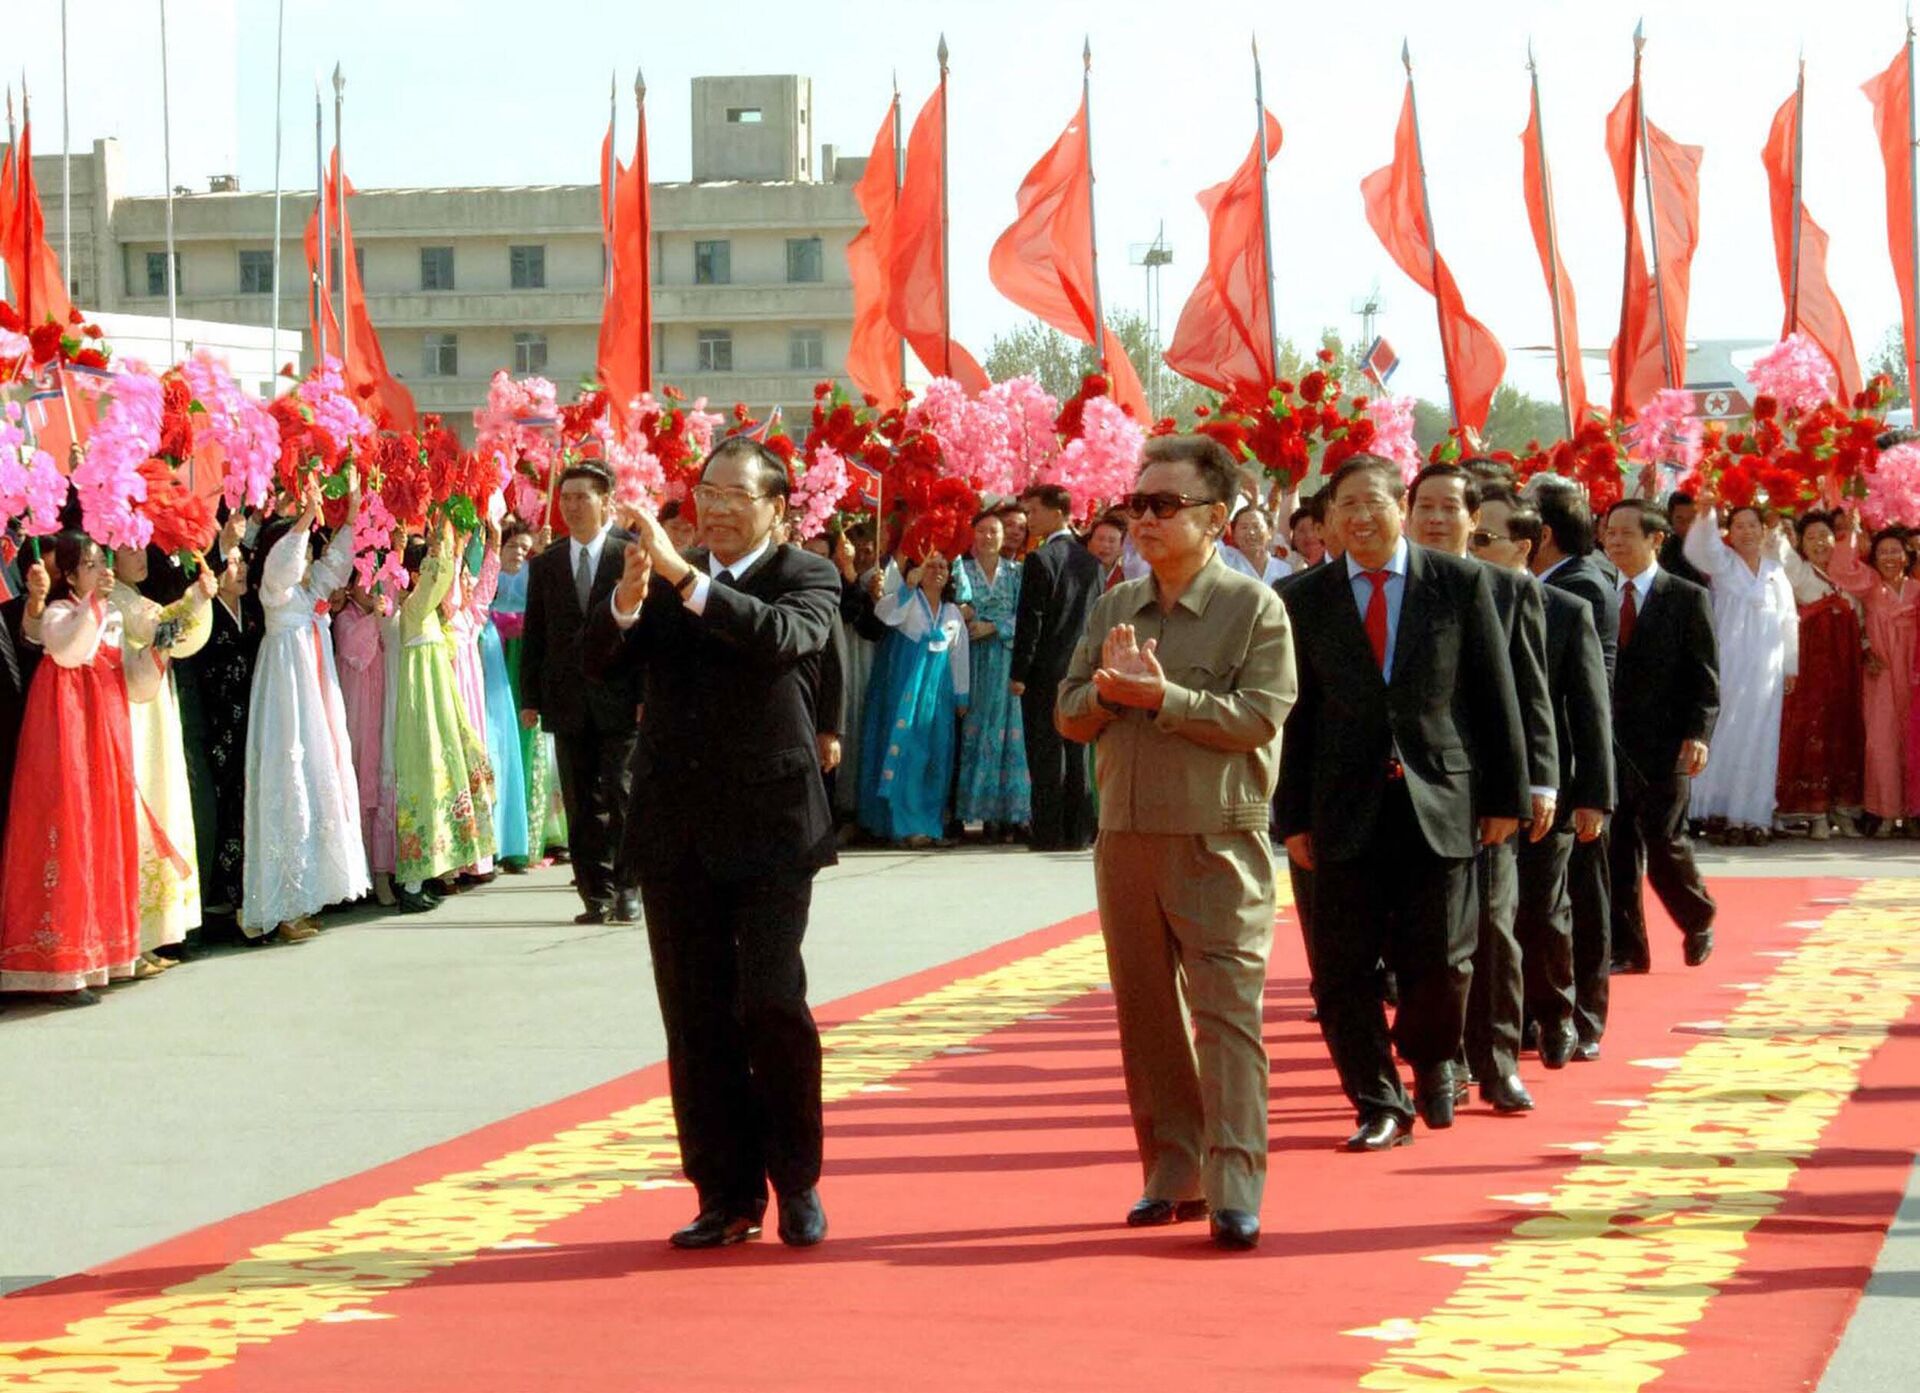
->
[[1008, 484, 1100, 852]]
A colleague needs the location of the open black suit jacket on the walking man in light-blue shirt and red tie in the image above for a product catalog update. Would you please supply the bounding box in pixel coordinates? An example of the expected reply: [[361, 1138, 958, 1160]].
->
[[1279, 545, 1532, 873]]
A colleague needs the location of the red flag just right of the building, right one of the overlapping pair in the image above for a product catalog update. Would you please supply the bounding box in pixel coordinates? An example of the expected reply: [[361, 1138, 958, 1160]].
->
[[885, 86, 987, 395]]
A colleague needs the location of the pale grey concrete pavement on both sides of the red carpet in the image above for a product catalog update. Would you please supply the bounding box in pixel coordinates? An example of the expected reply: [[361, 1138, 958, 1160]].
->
[[0, 840, 1920, 1393]]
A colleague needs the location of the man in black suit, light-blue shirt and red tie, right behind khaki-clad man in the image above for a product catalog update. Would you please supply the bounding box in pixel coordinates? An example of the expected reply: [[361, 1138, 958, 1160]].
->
[[1279, 455, 1530, 1151]]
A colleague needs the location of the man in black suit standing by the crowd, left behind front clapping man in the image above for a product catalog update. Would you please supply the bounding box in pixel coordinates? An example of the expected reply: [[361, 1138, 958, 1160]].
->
[[520, 462, 639, 923]]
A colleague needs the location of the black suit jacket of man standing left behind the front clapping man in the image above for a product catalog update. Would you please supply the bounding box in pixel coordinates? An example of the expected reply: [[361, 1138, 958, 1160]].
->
[[520, 528, 636, 735]]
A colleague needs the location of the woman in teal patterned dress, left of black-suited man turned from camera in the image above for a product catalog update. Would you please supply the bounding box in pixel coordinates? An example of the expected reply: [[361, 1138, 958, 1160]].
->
[[954, 512, 1033, 842]]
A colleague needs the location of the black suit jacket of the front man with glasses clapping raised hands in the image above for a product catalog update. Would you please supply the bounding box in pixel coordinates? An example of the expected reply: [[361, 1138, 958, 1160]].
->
[[584, 547, 841, 881]]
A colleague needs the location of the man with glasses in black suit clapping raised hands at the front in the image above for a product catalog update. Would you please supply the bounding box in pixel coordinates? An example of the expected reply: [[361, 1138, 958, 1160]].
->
[[586, 437, 841, 1247]]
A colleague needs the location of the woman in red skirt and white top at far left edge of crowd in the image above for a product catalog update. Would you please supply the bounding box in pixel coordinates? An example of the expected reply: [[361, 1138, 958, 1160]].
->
[[0, 533, 159, 1005]]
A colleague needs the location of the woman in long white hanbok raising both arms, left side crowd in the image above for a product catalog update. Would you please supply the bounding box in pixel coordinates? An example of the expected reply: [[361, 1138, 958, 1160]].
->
[[240, 482, 371, 942]]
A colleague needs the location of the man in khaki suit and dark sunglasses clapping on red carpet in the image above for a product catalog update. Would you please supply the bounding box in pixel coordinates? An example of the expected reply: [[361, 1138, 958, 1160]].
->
[[1054, 436, 1294, 1249]]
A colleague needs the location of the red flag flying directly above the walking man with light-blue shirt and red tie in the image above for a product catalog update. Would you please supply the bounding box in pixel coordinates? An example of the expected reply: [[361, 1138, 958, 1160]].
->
[[1359, 81, 1507, 430]]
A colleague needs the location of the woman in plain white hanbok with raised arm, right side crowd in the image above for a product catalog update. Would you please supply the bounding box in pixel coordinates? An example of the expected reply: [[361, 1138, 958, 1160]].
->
[[1684, 499, 1799, 846]]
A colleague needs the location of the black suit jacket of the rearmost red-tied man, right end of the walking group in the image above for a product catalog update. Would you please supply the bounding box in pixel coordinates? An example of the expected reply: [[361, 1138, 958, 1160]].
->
[[1613, 568, 1720, 792]]
